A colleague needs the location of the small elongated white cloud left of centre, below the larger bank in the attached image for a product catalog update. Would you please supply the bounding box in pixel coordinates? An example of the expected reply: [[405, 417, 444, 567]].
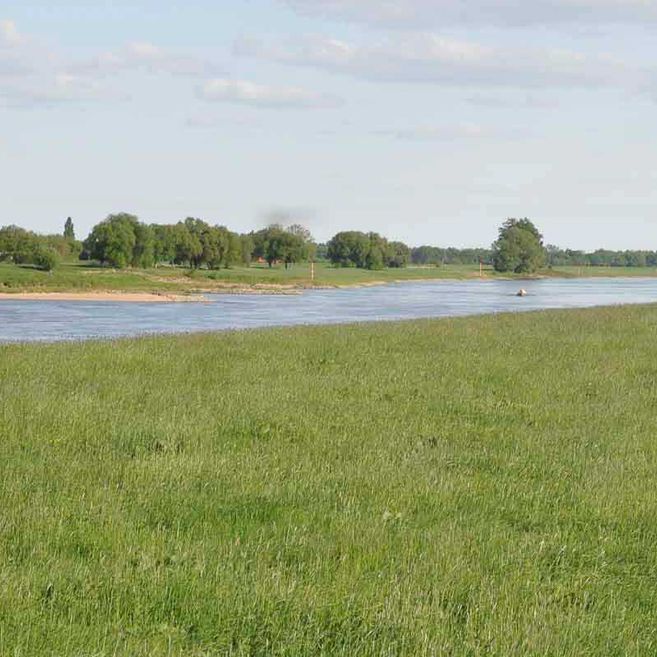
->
[[198, 79, 340, 108]]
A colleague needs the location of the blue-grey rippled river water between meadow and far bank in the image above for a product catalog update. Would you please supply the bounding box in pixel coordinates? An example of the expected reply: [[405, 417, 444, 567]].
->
[[0, 278, 657, 342]]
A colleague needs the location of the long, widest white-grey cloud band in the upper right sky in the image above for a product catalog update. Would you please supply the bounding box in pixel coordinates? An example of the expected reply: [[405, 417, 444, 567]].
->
[[235, 34, 642, 88]]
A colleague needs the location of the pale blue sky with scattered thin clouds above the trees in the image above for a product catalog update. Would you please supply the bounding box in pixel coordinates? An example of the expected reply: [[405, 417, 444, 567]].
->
[[0, 0, 657, 248]]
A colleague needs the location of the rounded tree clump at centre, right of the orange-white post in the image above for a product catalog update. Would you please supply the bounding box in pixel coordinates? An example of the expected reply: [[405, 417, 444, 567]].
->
[[326, 230, 410, 269]]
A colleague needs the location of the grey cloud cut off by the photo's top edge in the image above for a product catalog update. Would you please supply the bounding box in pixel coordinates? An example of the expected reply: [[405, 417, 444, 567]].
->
[[279, 0, 657, 28]]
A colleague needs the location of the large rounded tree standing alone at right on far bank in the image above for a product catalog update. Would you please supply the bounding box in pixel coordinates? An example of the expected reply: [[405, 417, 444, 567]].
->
[[493, 219, 546, 274]]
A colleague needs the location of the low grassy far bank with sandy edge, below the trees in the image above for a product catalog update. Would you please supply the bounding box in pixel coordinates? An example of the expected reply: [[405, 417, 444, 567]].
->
[[5, 262, 657, 293]]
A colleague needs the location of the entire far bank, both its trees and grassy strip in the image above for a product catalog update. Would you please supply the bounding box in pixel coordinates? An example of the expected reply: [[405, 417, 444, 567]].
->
[[0, 213, 657, 292]]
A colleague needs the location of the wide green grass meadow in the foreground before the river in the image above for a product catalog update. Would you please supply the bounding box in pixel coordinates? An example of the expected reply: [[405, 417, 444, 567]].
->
[[0, 307, 657, 657]]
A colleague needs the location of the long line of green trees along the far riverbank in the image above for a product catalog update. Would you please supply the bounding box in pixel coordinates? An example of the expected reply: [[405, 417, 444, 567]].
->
[[0, 213, 657, 273]]
